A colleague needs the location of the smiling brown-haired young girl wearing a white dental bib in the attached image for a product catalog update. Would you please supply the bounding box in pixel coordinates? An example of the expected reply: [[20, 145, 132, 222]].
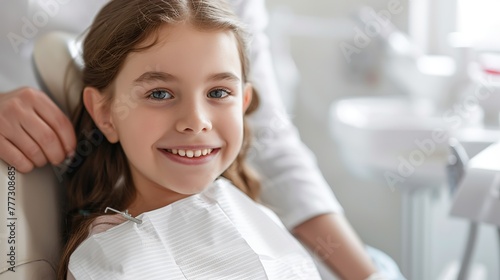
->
[[59, 0, 319, 279]]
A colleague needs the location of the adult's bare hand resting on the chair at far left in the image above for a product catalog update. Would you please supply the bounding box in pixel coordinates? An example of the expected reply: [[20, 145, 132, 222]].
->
[[0, 87, 76, 172]]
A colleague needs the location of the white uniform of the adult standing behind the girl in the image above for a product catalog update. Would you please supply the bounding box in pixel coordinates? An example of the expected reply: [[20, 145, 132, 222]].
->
[[0, 0, 342, 229]]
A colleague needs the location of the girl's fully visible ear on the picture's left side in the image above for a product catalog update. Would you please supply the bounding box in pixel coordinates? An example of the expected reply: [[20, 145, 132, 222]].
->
[[83, 87, 119, 143]]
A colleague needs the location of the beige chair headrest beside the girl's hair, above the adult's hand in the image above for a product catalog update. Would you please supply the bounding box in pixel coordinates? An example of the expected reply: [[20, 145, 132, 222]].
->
[[33, 32, 83, 116]]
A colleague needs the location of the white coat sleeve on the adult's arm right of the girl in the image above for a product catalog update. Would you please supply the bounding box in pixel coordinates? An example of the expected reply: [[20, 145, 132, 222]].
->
[[233, 0, 343, 229]]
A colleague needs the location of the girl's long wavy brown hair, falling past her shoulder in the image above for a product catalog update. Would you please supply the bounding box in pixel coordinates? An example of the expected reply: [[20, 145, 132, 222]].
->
[[58, 0, 260, 279]]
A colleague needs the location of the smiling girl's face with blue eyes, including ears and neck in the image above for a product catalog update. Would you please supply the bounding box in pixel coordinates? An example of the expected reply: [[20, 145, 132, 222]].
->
[[89, 24, 252, 214]]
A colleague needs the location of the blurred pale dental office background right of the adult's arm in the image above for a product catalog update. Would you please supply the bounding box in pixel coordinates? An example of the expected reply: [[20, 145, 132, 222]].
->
[[267, 0, 500, 279]]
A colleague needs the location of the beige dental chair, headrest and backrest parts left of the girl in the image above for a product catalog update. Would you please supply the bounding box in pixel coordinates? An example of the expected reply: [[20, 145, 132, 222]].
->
[[0, 33, 81, 280]]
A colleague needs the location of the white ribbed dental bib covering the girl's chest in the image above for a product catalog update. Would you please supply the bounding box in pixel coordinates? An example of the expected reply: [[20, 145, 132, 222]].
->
[[69, 179, 320, 280]]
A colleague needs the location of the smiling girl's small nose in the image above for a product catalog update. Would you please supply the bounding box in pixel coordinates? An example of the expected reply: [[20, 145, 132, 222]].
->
[[176, 104, 212, 134]]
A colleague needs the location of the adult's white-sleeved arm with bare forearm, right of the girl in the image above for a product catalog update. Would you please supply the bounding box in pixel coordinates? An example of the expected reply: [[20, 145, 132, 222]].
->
[[233, 0, 376, 279]]
